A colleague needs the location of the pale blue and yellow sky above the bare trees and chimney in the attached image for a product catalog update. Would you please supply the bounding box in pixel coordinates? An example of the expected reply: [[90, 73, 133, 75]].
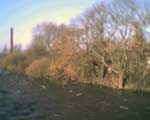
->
[[0, 0, 150, 49]]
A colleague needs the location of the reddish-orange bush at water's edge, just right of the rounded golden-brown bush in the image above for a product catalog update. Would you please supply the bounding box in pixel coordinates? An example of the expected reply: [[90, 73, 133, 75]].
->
[[49, 56, 77, 80]]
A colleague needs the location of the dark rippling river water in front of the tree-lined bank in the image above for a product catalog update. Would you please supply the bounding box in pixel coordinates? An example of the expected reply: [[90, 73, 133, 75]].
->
[[0, 72, 150, 120]]
